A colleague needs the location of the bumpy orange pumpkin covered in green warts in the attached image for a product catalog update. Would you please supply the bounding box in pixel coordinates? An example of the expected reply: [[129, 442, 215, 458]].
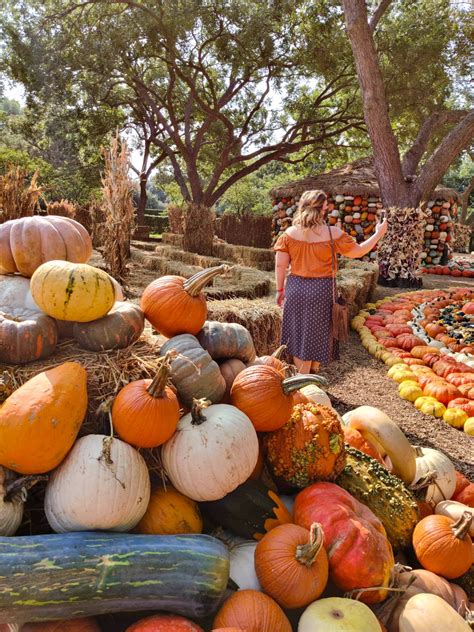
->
[[263, 404, 345, 489]]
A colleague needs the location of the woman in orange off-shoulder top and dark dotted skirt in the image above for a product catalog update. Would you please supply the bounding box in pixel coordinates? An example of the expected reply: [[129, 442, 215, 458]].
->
[[274, 191, 387, 373]]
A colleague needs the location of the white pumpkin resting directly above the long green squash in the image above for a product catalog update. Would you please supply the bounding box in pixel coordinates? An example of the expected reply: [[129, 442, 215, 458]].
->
[[44, 435, 150, 533]]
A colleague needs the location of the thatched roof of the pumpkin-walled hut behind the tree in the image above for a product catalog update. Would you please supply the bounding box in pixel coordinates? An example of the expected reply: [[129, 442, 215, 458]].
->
[[270, 157, 460, 202]]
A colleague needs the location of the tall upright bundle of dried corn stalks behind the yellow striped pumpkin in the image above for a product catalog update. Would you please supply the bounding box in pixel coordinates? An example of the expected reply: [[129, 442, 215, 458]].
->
[[98, 134, 135, 280]]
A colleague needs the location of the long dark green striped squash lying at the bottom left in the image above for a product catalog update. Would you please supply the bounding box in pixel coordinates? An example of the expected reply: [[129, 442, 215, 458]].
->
[[0, 532, 229, 623]]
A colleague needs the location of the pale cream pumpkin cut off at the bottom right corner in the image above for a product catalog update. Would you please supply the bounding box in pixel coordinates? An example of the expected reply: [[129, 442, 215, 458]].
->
[[398, 593, 471, 632]]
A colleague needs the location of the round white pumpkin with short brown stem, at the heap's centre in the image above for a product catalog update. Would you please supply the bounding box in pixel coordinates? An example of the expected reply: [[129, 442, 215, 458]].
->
[[161, 400, 259, 501]]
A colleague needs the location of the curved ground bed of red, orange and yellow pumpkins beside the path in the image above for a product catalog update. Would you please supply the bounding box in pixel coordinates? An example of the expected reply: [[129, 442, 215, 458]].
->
[[352, 288, 474, 436]]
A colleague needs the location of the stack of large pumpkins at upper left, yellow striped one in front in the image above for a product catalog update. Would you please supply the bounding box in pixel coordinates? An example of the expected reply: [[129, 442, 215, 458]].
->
[[0, 215, 145, 364]]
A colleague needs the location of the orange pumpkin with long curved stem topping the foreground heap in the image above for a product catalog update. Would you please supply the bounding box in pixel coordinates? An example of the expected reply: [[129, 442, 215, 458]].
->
[[140, 265, 229, 338]]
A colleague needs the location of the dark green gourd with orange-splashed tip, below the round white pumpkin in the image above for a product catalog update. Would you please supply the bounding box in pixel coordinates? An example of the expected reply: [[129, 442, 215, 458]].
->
[[199, 480, 292, 540]]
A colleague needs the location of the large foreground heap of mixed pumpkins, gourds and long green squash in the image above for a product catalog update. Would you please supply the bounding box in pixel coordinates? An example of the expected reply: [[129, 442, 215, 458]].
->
[[0, 264, 474, 632]]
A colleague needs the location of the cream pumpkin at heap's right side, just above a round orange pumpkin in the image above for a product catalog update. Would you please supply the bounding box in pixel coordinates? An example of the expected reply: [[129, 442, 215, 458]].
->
[[411, 447, 456, 507]]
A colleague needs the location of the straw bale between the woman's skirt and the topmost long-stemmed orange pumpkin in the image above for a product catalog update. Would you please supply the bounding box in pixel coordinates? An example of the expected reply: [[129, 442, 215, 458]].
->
[[207, 299, 281, 355]]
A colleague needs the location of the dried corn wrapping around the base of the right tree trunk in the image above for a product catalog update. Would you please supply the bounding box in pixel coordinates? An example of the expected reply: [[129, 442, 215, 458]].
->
[[378, 208, 426, 287]]
